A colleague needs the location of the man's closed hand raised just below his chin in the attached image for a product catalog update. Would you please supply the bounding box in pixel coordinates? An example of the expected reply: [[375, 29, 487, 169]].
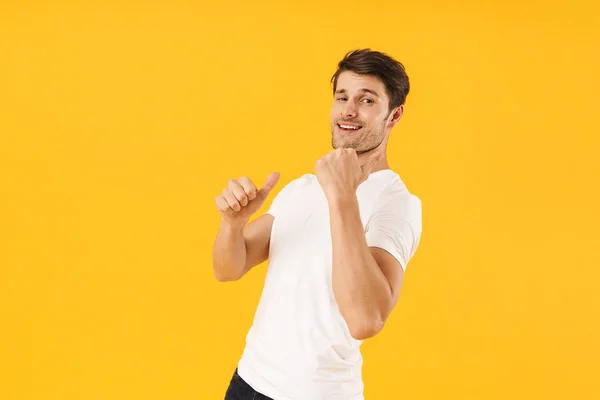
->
[[315, 149, 383, 200]]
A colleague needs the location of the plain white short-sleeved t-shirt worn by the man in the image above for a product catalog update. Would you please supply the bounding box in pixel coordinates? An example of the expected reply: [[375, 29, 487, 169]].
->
[[238, 169, 421, 400]]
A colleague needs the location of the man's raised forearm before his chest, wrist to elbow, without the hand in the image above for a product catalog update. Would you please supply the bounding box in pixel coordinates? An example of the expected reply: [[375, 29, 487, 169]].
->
[[329, 195, 392, 338]]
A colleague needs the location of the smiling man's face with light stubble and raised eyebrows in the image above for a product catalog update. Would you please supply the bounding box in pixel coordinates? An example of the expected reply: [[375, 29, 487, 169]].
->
[[331, 71, 397, 153]]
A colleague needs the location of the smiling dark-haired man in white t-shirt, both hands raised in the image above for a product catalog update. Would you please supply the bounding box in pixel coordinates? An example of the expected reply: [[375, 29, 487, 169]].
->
[[213, 49, 421, 400]]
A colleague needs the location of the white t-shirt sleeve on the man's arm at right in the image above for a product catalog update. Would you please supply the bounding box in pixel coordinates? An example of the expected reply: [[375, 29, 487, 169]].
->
[[365, 194, 422, 271]]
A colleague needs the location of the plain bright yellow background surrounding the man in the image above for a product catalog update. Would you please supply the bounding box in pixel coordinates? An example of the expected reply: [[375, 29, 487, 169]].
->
[[0, 0, 600, 400]]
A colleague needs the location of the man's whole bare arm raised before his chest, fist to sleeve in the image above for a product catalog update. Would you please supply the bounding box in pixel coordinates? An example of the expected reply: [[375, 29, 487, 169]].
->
[[315, 148, 404, 340]]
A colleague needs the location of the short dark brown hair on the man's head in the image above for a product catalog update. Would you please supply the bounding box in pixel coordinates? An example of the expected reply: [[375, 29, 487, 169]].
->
[[331, 48, 410, 111]]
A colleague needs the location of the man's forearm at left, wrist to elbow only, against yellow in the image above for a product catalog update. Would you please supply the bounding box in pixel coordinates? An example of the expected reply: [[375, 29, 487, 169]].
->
[[213, 220, 247, 281]]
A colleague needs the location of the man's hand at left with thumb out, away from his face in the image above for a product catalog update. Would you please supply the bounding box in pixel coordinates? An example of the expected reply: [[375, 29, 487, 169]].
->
[[216, 172, 279, 224]]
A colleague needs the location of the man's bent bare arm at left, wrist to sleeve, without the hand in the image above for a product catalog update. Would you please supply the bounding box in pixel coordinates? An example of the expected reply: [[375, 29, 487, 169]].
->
[[213, 214, 274, 282]]
